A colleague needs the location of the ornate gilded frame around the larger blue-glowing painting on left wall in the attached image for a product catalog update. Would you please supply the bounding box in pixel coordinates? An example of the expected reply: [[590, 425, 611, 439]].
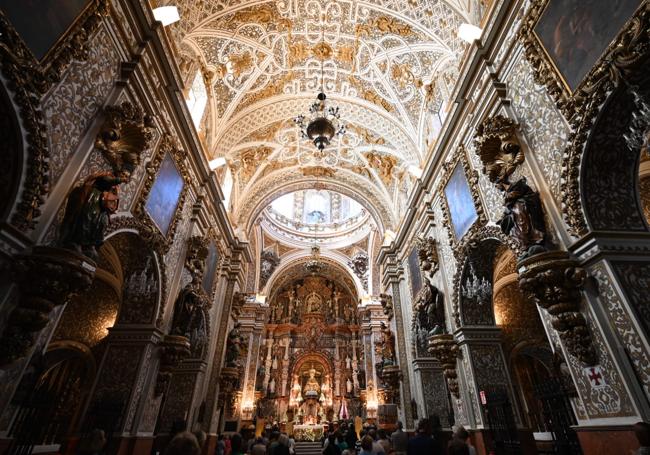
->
[[133, 134, 191, 254]]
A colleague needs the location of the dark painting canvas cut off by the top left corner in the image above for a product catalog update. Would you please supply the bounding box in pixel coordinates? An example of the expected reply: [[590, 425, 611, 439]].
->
[[0, 0, 90, 60]]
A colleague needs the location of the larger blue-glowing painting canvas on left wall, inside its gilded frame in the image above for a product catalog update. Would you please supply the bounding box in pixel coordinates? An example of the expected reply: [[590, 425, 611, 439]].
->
[[145, 154, 184, 235]]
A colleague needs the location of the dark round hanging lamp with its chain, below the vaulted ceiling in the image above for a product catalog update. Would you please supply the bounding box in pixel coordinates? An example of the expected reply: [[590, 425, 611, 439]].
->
[[293, 27, 345, 152]]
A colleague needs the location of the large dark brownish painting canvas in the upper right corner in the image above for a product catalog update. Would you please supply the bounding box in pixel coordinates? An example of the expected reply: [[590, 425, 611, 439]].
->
[[534, 0, 641, 93]]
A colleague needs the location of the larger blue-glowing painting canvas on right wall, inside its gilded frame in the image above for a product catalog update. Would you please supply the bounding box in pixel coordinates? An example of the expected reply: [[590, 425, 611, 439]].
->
[[445, 164, 478, 240]]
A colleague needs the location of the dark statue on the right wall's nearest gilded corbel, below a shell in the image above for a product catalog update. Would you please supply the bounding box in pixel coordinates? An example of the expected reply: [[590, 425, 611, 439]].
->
[[498, 177, 547, 259]]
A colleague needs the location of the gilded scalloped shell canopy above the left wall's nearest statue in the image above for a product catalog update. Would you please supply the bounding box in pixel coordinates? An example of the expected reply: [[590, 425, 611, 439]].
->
[[95, 101, 154, 173]]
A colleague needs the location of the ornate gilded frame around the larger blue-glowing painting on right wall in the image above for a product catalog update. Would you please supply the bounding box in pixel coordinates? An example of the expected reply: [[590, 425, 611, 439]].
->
[[437, 145, 488, 258]]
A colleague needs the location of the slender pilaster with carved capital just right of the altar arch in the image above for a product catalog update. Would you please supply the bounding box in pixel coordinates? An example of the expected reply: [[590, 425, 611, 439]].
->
[[382, 255, 414, 428]]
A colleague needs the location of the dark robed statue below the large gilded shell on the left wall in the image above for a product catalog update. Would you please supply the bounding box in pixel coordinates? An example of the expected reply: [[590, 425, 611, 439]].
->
[[59, 166, 133, 259]]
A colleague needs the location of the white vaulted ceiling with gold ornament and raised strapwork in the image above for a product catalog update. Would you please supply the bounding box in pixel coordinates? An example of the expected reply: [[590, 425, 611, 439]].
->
[[162, 0, 482, 232]]
